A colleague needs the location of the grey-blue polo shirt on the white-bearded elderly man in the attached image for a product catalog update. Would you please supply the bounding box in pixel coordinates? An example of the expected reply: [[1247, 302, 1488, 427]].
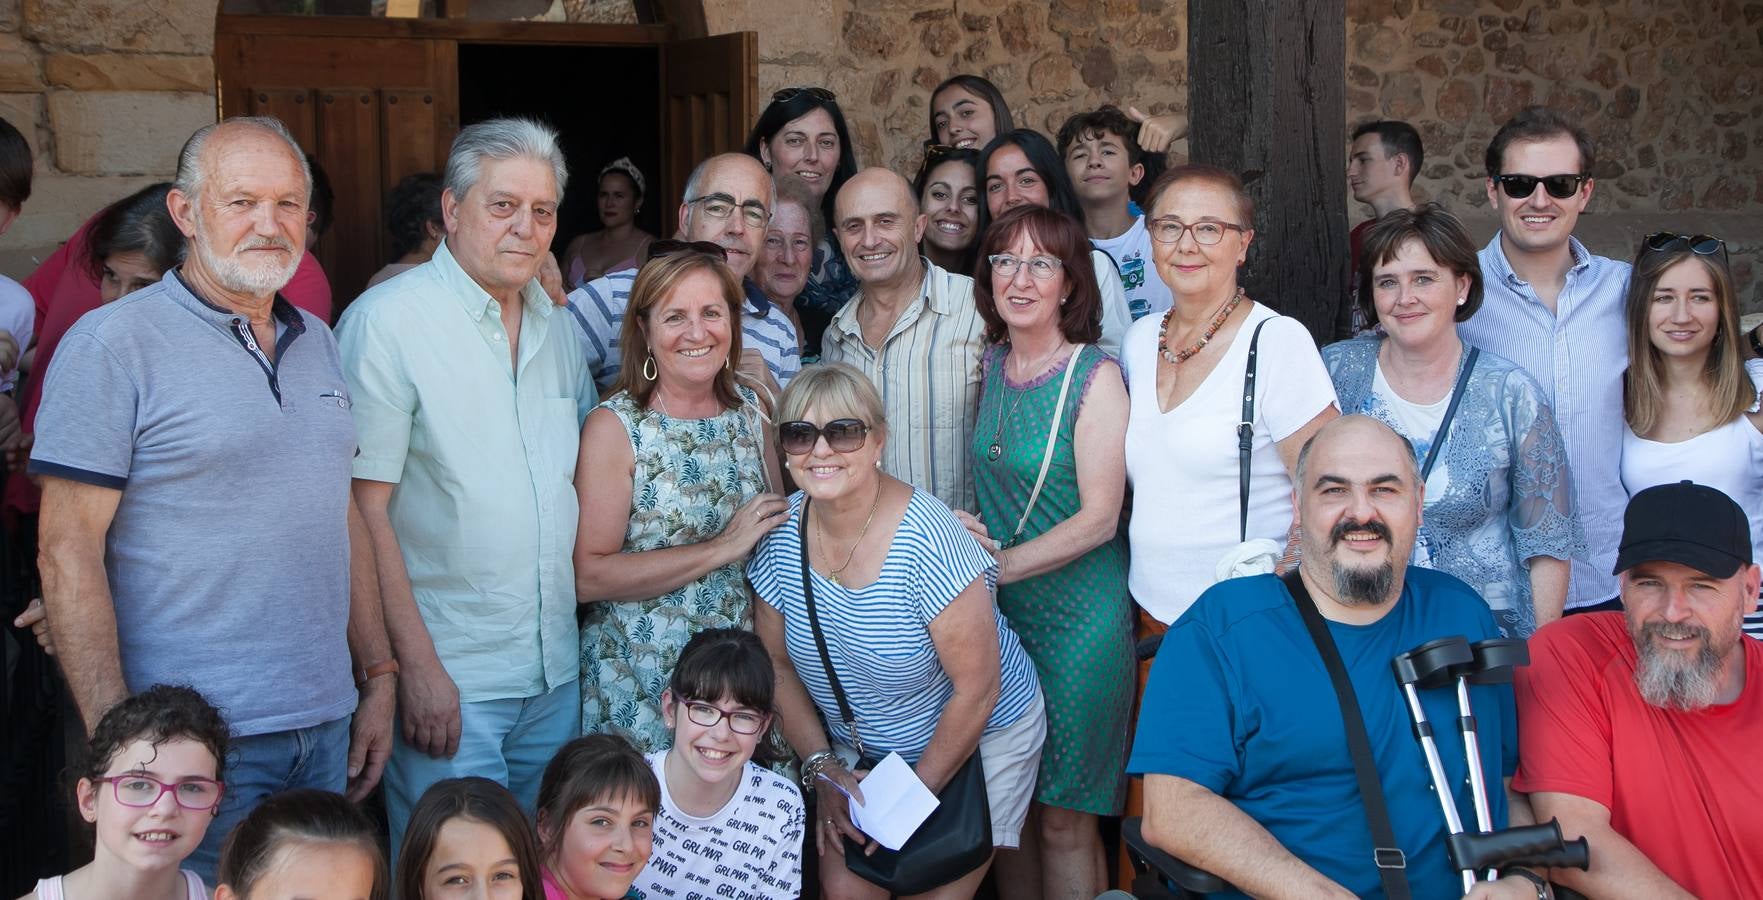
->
[[30, 270, 356, 736]]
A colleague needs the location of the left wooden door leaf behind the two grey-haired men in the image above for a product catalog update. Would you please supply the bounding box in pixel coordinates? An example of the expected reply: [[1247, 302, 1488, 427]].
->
[[215, 16, 458, 312]]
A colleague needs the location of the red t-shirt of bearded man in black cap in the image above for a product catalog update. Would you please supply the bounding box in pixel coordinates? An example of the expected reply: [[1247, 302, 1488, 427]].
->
[[1513, 612, 1763, 900]]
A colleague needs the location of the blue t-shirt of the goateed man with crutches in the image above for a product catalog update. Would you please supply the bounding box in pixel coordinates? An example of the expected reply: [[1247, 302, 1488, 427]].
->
[[1127, 566, 1518, 898]]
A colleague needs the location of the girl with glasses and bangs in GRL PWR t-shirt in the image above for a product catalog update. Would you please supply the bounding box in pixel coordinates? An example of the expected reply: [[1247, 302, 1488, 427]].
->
[[636, 628, 804, 898]]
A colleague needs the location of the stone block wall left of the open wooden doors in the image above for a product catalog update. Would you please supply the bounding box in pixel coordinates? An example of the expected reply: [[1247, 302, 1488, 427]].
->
[[0, 0, 217, 277]]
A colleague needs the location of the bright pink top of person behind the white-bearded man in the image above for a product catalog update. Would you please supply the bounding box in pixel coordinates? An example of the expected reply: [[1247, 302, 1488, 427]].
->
[[5, 215, 331, 512]]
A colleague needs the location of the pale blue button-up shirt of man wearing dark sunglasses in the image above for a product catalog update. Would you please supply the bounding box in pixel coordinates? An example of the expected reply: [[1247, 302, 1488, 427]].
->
[[1458, 235, 1629, 609]]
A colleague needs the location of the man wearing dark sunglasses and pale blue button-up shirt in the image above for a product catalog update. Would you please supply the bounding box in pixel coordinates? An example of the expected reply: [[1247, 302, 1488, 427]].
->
[[1458, 106, 1629, 626]]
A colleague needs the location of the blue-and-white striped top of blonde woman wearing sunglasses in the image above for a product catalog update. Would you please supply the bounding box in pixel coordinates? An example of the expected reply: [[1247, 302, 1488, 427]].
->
[[748, 491, 1040, 762]]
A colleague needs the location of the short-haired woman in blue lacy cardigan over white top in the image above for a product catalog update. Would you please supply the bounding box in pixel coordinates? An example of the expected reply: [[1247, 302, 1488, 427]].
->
[[1322, 203, 1583, 637]]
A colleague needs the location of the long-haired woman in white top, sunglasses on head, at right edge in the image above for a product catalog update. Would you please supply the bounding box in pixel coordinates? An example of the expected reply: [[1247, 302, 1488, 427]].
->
[[1622, 233, 1763, 637]]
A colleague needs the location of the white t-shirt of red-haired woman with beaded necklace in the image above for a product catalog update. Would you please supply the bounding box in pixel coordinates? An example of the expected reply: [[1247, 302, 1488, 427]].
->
[[1121, 304, 1335, 623]]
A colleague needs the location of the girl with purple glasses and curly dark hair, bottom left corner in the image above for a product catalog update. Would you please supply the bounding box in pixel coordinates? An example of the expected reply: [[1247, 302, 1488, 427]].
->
[[28, 685, 227, 900]]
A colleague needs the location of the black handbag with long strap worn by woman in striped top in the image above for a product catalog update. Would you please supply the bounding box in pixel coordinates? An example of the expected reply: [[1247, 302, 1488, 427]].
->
[[797, 498, 993, 895]]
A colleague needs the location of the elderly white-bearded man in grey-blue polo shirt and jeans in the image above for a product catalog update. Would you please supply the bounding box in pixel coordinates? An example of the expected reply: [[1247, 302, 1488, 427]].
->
[[30, 118, 397, 879]]
